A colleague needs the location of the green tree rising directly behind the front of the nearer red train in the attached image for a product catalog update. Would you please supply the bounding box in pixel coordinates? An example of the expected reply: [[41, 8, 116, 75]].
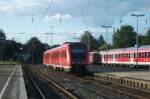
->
[[80, 31, 99, 50]]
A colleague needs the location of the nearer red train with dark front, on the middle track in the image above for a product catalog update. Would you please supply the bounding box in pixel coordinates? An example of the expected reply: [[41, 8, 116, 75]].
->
[[43, 42, 88, 72]]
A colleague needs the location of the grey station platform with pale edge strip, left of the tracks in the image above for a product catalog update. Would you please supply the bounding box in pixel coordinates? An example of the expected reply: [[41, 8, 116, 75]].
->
[[0, 65, 27, 99]]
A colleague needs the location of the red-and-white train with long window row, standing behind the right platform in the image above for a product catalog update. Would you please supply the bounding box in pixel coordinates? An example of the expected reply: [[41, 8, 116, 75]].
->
[[99, 45, 150, 68]]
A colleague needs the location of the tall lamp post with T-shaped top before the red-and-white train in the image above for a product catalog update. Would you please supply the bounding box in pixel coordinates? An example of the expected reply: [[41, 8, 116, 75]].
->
[[131, 14, 145, 65]]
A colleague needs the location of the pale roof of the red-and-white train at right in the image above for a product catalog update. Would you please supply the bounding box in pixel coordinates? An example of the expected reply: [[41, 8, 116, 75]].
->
[[100, 45, 150, 54]]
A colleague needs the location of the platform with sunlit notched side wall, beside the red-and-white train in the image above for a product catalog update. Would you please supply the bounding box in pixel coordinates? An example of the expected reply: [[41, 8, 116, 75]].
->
[[90, 66, 150, 91]]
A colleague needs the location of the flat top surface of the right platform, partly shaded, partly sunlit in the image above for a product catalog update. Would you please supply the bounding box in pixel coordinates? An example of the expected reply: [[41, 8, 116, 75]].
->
[[89, 65, 150, 81]]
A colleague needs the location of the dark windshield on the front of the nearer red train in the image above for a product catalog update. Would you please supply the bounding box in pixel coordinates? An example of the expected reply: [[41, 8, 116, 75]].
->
[[70, 43, 87, 60]]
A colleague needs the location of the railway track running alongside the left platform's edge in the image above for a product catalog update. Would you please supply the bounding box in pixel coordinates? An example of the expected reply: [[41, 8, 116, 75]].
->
[[23, 65, 78, 99]]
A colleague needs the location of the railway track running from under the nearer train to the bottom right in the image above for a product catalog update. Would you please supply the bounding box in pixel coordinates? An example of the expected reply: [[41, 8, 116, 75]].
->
[[33, 65, 150, 99]]
